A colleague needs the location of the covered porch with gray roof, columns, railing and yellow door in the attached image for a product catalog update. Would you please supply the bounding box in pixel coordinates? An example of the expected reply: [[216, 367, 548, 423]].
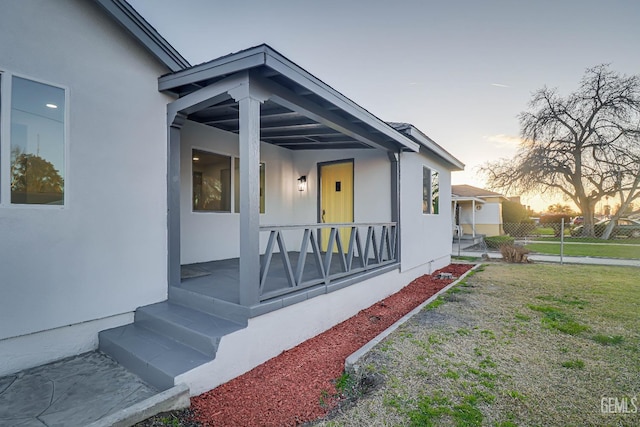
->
[[159, 45, 418, 317]]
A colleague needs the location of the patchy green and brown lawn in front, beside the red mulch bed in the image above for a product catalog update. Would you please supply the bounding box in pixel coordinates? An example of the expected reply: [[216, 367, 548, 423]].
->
[[319, 263, 640, 427]]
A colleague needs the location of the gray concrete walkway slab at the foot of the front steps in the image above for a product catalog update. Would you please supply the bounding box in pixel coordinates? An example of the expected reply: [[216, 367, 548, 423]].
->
[[0, 352, 188, 427]]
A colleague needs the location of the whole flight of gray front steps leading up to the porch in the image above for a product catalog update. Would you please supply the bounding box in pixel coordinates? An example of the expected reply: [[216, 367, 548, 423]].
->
[[99, 294, 247, 390]]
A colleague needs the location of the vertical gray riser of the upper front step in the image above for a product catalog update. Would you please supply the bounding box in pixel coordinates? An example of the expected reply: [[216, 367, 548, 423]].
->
[[135, 307, 220, 358]]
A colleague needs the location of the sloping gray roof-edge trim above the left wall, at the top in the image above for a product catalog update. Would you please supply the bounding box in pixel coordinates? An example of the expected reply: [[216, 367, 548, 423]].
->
[[93, 0, 191, 71]]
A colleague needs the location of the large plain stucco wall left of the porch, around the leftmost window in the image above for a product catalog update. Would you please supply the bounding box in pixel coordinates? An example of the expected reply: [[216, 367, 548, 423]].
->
[[0, 0, 169, 354]]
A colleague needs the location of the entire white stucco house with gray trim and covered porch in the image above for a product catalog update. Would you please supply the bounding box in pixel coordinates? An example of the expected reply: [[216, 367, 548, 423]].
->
[[0, 0, 463, 395]]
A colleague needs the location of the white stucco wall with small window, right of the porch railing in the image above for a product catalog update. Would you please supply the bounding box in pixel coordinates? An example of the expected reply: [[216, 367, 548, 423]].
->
[[400, 153, 452, 271]]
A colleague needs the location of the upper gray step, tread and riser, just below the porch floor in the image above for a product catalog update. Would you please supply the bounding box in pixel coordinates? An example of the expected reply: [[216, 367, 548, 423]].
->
[[135, 301, 245, 359]]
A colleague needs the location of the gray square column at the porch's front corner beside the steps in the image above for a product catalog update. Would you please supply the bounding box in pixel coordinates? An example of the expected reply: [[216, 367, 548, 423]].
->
[[229, 82, 265, 306]]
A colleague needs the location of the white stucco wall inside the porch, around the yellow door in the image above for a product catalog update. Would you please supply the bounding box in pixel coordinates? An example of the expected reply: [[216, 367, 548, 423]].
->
[[180, 134, 391, 264]]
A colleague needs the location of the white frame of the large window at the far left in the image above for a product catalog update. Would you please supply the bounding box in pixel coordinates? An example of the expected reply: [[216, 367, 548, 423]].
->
[[0, 69, 71, 210]]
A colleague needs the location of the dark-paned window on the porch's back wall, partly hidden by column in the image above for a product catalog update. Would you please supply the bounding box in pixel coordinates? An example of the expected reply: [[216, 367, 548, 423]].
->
[[192, 150, 265, 213]]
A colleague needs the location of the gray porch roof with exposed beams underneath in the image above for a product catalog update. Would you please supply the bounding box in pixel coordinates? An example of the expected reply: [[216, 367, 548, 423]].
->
[[158, 45, 420, 152]]
